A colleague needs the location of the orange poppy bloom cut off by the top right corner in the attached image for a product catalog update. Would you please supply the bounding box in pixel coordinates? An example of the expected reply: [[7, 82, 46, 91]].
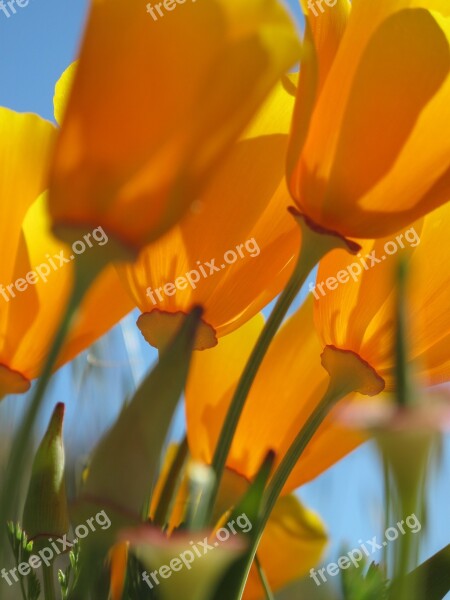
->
[[288, 0, 450, 238]]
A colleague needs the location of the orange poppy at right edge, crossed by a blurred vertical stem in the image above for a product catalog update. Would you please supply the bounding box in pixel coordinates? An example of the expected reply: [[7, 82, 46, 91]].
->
[[313, 204, 450, 390]]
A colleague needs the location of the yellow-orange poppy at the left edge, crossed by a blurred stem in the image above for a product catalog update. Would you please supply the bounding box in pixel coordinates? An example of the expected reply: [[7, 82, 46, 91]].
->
[[0, 108, 132, 398]]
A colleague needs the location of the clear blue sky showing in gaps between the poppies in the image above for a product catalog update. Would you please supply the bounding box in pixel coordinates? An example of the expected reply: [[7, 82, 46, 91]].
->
[[0, 0, 450, 596]]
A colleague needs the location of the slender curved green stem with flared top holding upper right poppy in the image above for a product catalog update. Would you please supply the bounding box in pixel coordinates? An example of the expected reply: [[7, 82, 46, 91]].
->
[[206, 211, 359, 521]]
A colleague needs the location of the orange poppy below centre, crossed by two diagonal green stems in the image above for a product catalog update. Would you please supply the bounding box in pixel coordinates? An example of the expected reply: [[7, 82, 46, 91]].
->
[[186, 299, 370, 492]]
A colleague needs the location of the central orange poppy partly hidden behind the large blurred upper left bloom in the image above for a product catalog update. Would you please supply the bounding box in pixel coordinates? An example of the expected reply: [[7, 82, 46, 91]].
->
[[120, 80, 300, 349]]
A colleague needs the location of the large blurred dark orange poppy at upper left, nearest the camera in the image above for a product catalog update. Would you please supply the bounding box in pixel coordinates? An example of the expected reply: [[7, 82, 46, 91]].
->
[[50, 0, 299, 251]]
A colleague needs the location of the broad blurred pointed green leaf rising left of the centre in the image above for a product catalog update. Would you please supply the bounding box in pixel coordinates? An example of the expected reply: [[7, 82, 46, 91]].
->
[[83, 309, 204, 517]]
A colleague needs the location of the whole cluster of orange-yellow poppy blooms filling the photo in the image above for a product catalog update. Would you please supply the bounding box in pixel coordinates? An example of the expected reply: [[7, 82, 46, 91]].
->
[[0, 0, 450, 600]]
